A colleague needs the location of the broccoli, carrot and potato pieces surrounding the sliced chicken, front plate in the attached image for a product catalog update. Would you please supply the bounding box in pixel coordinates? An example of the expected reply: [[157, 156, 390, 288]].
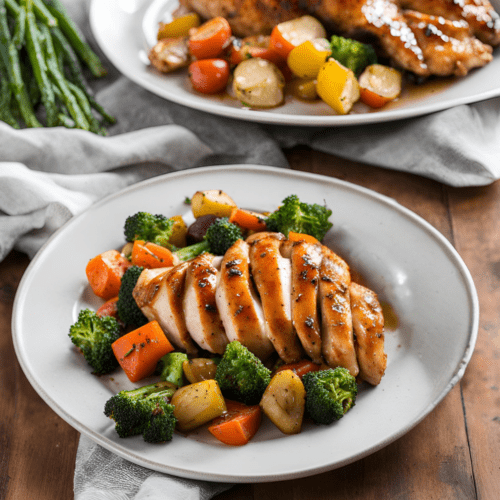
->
[[69, 190, 372, 446]]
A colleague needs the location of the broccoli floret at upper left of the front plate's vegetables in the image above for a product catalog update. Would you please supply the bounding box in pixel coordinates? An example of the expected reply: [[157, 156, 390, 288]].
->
[[123, 212, 174, 247]]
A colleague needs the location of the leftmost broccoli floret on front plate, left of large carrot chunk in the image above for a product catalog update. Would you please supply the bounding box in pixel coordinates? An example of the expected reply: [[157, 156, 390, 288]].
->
[[69, 309, 120, 375]]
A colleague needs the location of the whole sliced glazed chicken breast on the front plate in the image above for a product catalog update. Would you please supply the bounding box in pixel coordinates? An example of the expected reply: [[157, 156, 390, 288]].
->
[[134, 236, 387, 385]]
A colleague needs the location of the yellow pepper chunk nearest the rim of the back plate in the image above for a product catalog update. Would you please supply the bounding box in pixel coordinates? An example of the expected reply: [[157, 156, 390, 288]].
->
[[316, 59, 360, 115]]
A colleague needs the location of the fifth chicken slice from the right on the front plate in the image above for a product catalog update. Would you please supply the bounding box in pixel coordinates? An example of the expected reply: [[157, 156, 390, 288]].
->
[[215, 240, 274, 360]]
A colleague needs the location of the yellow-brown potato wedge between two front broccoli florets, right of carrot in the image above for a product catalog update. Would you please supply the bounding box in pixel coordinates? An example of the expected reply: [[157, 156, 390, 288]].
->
[[260, 370, 306, 434]]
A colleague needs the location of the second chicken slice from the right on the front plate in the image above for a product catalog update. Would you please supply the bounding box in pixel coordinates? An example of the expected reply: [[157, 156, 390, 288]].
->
[[319, 246, 359, 376]]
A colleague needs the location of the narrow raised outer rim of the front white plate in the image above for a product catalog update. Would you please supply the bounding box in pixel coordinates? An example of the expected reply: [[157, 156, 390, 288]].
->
[[11, 164, 479, 483]]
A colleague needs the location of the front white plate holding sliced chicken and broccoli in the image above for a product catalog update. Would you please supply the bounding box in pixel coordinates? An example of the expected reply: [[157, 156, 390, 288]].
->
[[13, 165, 478, 482]]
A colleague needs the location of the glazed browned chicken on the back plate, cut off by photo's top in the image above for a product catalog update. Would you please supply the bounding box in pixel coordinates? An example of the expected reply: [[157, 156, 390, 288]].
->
[[181, 0, 500, 78]]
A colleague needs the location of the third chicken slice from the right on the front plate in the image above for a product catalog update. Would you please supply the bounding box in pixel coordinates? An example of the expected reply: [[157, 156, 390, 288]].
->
[[291, 241, 323, 364]]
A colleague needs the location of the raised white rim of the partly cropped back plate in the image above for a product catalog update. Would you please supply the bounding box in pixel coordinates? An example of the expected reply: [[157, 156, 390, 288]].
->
[[89, 0, 500, 127]]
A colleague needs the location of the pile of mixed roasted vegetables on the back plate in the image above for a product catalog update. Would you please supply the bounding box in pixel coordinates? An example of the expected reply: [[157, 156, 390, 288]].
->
[[149, 13, 402, 115]]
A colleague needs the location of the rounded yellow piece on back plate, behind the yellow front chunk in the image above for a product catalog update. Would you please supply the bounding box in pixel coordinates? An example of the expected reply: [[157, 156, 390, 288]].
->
[[287, 38, 332, 78]]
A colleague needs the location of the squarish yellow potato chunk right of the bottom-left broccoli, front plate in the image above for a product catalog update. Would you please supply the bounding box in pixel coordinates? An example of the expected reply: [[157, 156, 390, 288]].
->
[[171, 380, 226, 432]]
